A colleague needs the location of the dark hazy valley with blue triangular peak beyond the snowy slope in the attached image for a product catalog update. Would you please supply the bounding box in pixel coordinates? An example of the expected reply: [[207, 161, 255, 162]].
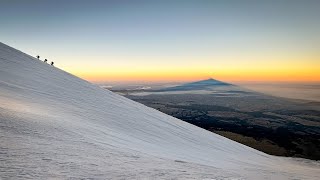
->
[[110, 80, 320, 160]]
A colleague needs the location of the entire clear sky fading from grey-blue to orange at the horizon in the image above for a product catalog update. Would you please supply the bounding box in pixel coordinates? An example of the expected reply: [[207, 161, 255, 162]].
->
[[0, 0, 320, 82]]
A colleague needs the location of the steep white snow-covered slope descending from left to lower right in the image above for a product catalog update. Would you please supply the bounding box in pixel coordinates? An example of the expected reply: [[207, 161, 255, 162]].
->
[[0, 43, 320, 179]]
